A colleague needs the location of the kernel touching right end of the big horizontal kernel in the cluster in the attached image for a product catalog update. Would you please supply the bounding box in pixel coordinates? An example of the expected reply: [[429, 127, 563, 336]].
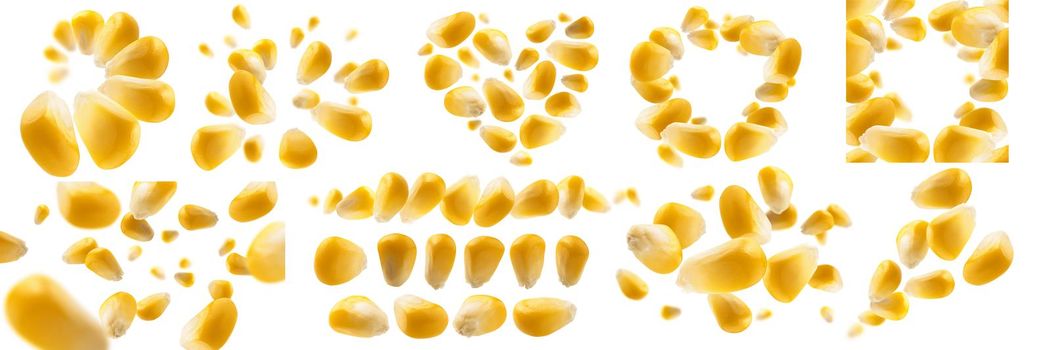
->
[[763, 245, 818, 303]]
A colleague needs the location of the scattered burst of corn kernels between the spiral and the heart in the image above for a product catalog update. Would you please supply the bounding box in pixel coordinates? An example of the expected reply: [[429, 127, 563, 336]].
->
[[190, 5, 390, 170]]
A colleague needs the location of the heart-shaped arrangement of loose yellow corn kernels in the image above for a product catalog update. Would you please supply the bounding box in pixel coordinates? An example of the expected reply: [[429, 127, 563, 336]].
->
[[419, 12, 599, 166]]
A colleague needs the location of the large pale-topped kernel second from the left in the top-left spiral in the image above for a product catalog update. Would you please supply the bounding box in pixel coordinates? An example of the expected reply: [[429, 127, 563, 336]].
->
[[74, 91, 140, 169]]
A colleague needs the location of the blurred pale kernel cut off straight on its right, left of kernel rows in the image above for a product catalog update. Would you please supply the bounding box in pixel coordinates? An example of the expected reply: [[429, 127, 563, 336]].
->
[[245, 222, 285, 283]]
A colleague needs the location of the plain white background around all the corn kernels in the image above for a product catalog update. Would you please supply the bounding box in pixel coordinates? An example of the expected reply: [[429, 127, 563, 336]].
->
[[0, 0, 1049, 349]]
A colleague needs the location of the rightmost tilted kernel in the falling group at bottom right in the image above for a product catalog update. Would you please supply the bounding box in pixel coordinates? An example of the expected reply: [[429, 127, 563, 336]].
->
[[964, 231, 1014, 286]]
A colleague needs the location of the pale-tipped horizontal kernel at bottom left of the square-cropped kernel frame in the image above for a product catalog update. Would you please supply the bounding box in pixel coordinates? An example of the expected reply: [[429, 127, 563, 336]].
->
[[859, 125, 930, 163]]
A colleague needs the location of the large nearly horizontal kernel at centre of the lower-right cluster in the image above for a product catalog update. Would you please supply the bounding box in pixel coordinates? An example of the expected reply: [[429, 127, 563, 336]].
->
[[677, 238, 767, 293]]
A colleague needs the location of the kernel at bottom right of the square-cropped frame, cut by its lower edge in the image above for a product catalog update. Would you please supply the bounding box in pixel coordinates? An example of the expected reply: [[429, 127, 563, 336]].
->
[[933, 125, 996, 163]]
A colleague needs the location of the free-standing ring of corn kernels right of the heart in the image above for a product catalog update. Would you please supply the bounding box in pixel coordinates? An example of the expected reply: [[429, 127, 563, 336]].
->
[[630, 6, 802, 163]]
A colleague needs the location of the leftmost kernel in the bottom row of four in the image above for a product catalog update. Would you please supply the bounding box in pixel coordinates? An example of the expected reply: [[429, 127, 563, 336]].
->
[[329, 295, 390, 337]]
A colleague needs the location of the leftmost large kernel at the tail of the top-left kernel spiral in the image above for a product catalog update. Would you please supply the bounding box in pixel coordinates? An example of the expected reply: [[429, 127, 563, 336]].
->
[[21, 91, 80, 177]]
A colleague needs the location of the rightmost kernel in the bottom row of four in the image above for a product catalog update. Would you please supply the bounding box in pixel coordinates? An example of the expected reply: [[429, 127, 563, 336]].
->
[[513, 297, 577, 336]]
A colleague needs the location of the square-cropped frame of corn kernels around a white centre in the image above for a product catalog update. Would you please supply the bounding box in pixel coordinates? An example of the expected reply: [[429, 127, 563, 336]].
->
[[846, 0, 1009, 163]]
